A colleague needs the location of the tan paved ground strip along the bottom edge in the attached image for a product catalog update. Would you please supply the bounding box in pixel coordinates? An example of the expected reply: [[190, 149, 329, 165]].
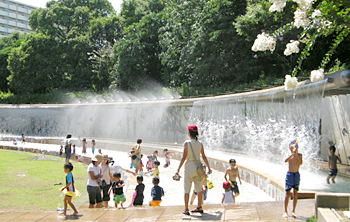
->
[[0, 200, 315, 222]]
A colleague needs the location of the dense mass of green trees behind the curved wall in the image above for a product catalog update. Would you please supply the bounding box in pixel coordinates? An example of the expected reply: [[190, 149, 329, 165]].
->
[[0, 0, 350, 102]]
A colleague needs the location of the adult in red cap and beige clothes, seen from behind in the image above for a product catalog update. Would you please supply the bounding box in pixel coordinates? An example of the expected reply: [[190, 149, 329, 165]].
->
[[175, 125, 211, 215]]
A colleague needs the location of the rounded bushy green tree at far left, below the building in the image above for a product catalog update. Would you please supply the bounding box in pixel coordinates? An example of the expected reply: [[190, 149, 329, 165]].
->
[[7, 33, 63, 94]]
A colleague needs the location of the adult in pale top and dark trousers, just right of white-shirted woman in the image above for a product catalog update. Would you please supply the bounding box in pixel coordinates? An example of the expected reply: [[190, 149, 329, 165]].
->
[[100, 155, 113, 208]]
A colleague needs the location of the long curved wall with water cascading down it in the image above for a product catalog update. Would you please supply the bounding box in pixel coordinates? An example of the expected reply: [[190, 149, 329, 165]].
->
[[0, 76, 350, 166]]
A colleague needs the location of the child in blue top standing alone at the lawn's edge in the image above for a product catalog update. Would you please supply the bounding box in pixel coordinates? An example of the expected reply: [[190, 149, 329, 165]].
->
[[61, 163, 78, 216]]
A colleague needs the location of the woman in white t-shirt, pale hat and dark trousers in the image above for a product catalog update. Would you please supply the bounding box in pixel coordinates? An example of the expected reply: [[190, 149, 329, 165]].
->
[[86, 154, 103, 208]]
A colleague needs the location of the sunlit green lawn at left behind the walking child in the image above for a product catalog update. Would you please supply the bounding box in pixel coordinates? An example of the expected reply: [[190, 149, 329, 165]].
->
[[0, 150, 88, 211]]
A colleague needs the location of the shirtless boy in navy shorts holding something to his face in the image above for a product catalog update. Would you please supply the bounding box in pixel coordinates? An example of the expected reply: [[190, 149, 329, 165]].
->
[[283, 140, 303, 218]]
